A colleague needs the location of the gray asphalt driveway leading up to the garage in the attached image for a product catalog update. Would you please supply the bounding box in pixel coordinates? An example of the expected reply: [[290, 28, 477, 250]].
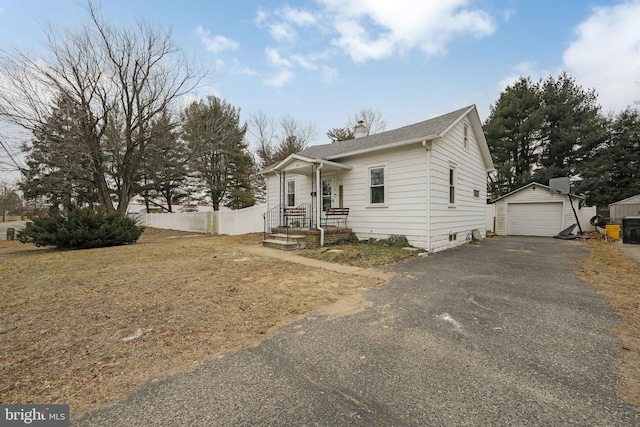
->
[[72, 238, 640, 426]]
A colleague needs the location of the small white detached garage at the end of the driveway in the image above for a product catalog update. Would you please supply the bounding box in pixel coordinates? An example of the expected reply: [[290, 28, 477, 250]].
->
[[493, 182, 582, 237]]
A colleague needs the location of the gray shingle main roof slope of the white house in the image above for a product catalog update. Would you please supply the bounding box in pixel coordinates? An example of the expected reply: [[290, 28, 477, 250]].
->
[[298, 105, 473, 159]]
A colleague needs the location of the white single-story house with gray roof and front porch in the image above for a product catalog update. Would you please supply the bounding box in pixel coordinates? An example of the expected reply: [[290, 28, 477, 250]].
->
[[263, 106, 494, 252]]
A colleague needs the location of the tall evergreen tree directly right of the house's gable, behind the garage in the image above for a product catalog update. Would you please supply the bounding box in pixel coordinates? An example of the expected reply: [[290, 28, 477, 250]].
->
[[484, 77, 543, 198]]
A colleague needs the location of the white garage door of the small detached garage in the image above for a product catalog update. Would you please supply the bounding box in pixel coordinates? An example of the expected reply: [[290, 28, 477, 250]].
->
[[507, 202, 563, 236]]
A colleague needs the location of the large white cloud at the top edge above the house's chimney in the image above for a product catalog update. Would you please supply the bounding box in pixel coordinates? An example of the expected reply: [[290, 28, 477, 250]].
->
[[318, 0, 495, 62]]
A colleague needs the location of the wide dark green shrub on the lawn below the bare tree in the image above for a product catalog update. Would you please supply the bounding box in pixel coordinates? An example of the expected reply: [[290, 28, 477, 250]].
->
[[17, 205, 144, 249]]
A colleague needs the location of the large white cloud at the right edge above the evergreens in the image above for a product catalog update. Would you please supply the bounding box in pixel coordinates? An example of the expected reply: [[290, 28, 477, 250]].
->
[[563, 0, 640, 110]]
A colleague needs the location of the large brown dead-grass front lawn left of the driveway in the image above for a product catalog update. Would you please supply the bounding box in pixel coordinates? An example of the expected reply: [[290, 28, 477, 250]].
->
[[0, 230, 379, 415]]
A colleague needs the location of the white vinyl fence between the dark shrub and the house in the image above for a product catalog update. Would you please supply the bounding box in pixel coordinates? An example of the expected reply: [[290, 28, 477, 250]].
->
[[138, 204, 266, 235]]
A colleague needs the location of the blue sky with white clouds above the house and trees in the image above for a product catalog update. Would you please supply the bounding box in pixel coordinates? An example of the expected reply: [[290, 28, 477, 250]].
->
[[0, 0, 640, 159]]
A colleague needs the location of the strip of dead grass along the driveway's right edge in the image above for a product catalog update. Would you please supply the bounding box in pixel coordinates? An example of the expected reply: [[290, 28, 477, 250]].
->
[[581, 240, 640, 407]]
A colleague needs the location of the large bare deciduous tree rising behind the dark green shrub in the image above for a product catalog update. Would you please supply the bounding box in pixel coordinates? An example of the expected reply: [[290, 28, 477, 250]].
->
[[0, 2, 205, 214]]
